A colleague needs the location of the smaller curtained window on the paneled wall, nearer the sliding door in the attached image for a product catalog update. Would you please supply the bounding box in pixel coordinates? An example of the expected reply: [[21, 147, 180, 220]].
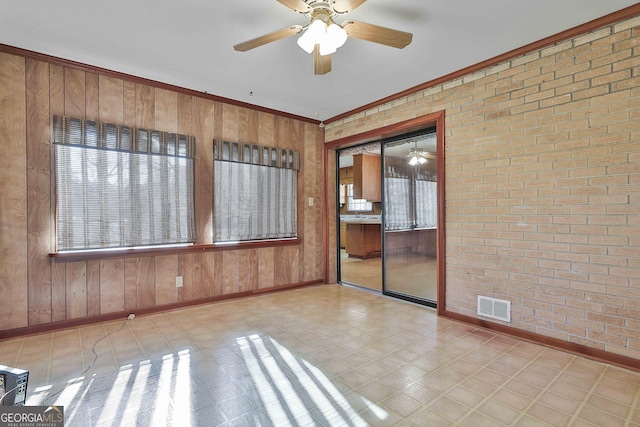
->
[[213, 141, 299, 242]]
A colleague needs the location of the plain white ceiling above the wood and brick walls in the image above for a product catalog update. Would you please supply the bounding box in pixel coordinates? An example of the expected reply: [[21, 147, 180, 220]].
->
[[0, 0, 636, 120]]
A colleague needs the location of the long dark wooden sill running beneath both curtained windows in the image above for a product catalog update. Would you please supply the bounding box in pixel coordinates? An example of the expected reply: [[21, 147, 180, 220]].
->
[[49, 238, 301, 262]]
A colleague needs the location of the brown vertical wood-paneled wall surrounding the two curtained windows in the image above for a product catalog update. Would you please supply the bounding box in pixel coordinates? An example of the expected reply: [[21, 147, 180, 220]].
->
[[0, 53, 324, 330]]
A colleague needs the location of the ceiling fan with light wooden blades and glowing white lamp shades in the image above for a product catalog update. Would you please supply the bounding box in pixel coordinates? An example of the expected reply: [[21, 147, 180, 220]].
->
[[233, 0, 413, 75]]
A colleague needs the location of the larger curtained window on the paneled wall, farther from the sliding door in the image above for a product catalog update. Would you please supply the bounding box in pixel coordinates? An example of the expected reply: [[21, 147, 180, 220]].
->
[[54, 117, 195, 251]]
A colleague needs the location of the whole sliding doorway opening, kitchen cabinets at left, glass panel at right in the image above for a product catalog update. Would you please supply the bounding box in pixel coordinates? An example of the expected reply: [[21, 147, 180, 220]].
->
[[336, 128, 444, 307]]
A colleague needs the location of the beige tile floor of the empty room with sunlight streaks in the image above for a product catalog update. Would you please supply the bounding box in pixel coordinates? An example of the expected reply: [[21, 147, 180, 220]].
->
[[0, 285, 640, 427]]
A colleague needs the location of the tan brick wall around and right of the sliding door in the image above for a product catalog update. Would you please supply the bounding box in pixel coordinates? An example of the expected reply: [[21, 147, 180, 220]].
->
[[325, 17, 640, 359]]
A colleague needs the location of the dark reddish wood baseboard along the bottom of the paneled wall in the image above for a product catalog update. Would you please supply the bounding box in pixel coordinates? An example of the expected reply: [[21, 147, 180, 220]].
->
[[0, 280, 324, 339]]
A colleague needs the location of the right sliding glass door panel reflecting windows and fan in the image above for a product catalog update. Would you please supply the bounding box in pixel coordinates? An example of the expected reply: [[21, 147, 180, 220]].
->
[[383, 131, 438, 306]]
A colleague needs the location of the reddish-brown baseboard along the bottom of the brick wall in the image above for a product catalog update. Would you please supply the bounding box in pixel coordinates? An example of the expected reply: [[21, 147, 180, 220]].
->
[[439, 310, 640, 372]]
